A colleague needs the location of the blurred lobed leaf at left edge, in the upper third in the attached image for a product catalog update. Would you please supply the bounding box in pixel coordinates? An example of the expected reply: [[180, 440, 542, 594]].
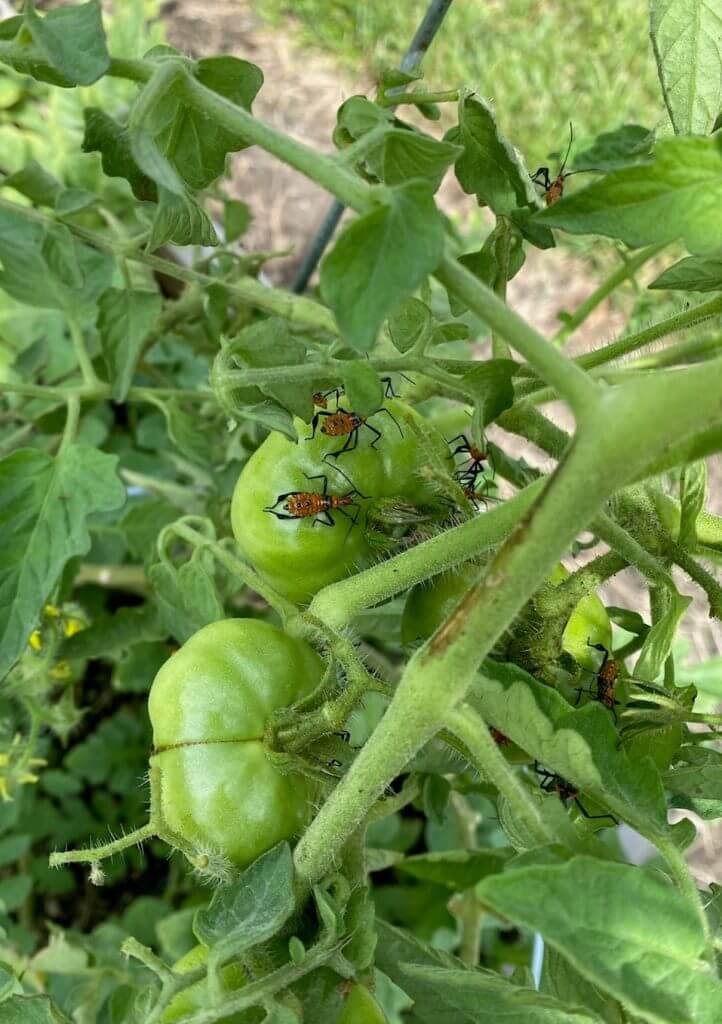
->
[[0, 202, 114, 311]]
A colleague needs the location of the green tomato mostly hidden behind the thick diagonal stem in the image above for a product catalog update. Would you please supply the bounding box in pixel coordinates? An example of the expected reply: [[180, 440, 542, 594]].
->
[[401, 563, 611, 671]]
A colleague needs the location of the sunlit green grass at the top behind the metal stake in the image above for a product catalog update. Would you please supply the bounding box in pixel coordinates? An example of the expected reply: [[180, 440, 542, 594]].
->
[[254, 0, 664, 167]]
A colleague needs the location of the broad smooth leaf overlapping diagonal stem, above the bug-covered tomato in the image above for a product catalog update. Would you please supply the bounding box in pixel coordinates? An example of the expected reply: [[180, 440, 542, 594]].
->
[[321, 181, 443, 351]]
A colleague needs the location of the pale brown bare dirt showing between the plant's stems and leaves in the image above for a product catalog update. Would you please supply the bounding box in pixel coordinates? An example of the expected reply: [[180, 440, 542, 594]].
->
[[163, 0, 722, 882]]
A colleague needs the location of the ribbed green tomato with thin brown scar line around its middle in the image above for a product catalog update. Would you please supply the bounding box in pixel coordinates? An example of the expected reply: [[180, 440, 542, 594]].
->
[[148, 618, 324, 867]]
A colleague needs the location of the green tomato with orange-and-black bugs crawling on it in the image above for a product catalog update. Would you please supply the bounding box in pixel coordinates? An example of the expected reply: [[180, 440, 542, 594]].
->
[[230, 397, 449, 603]]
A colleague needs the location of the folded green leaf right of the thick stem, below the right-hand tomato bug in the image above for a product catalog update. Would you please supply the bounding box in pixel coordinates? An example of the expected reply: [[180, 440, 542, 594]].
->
[[469, 660, 669, 836]]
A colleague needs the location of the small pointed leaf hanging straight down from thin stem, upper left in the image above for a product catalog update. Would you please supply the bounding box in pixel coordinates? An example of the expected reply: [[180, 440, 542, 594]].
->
[[97, 288, 163, 401]]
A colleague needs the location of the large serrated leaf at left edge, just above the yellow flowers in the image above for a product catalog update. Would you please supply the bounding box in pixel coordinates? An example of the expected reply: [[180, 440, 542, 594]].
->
[[0, 444, 125, 678]]
